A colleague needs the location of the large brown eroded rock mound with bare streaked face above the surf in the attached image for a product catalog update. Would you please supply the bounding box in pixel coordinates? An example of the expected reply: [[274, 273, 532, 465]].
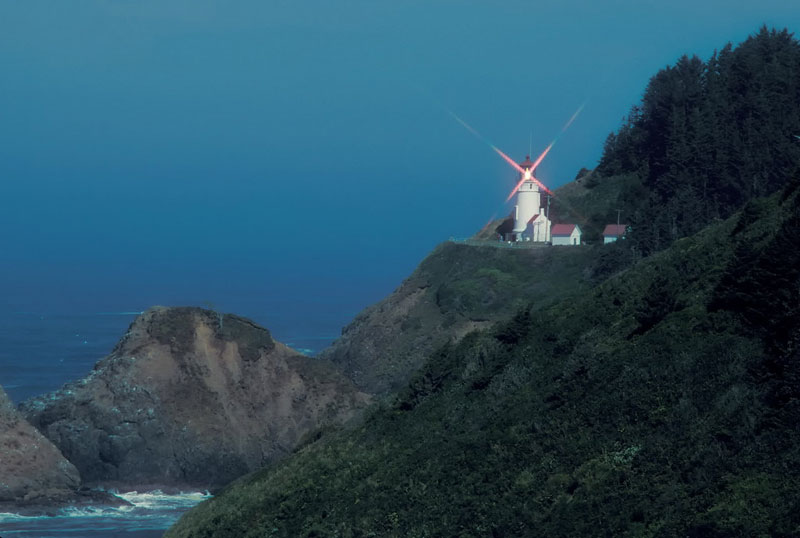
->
[[21, 307, 369, 487]]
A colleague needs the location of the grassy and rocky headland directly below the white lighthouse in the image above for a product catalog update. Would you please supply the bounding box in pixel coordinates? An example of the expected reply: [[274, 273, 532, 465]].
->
[[321, 242, 608, 393]]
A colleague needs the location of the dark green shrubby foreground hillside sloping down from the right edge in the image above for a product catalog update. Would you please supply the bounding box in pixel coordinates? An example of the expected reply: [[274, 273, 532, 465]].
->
[[166, 175, 800, 538]]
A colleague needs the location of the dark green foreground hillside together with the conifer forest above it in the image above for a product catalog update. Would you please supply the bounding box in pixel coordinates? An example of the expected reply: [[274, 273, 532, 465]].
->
[[167, 29, 800, 538]]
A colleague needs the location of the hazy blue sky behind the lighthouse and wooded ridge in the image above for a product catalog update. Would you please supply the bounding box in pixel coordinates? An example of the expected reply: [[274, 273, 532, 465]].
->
[[0, 0, 800, 340]]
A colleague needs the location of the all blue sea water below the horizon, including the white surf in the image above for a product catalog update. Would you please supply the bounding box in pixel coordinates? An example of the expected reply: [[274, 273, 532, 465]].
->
[[0, 309, 350, 538]]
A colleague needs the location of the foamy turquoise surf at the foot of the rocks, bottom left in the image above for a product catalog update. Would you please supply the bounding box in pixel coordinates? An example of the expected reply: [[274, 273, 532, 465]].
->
[[0, 490, 210, 538]]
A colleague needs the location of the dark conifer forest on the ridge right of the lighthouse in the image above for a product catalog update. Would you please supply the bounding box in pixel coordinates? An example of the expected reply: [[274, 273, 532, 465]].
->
[[553, 28, 800, 254]]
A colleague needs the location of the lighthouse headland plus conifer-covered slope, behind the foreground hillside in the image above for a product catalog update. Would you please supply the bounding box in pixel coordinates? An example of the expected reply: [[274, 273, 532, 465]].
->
[[322, 28, 800, 393]]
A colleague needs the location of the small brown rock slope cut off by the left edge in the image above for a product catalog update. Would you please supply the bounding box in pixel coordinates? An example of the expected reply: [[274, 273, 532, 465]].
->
[[0, 387, 81, 503]]
